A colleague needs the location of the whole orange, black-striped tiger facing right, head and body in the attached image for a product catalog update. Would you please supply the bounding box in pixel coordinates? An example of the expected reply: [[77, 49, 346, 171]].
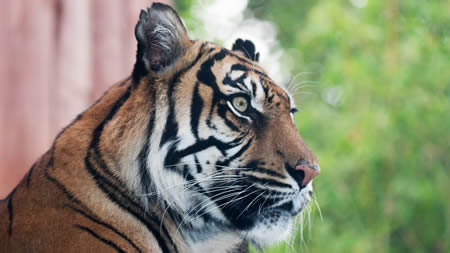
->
[[0, 3, 320, 253]]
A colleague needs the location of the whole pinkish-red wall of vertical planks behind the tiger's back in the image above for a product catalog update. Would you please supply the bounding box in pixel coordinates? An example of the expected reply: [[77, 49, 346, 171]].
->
[[0, 0, 170, 199]]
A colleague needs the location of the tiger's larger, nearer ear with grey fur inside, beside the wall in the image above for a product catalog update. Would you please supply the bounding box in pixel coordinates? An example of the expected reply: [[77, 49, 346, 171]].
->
[[135, 3, 189, 74]]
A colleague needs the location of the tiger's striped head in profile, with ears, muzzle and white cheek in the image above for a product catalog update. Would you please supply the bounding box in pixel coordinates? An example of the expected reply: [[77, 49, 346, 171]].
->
[[132, 4, 319, 249]]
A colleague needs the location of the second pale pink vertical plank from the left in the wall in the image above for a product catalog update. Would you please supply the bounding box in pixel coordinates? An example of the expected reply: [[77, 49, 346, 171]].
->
[[51, 0, 92, 135]]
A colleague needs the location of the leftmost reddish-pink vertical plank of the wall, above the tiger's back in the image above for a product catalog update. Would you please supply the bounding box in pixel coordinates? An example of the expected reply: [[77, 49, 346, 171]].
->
[[0, 0, 54, 195]]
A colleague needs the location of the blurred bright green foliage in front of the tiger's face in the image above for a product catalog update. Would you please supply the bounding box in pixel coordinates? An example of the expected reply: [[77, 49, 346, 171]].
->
[[177, 0, 450, 252]]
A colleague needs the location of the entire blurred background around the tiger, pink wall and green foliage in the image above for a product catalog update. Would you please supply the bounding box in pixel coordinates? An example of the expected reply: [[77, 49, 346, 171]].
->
[[0, 0, 450, 252]]
